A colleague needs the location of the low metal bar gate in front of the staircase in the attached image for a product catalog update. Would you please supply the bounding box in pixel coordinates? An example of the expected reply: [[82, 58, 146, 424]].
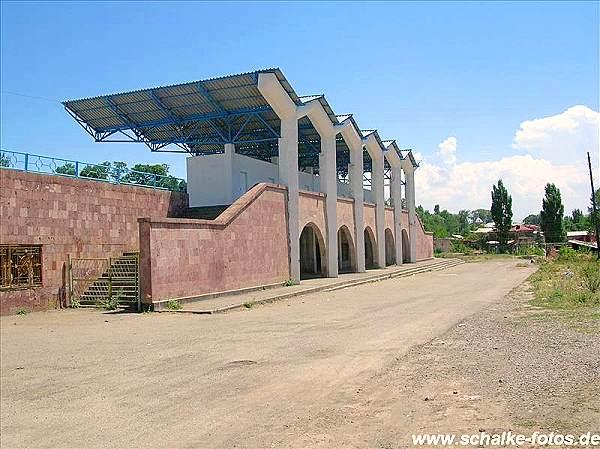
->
[[67, 253, 141, 310]]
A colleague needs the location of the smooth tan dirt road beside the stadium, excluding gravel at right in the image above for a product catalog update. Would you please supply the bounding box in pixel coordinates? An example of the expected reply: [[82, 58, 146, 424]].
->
[[0, 260, 533, 448]]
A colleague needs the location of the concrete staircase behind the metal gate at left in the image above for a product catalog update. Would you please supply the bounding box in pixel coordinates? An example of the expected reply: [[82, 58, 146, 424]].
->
[[79, 252, 139, 307]]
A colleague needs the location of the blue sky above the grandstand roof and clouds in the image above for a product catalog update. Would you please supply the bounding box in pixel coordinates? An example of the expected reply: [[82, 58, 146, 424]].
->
[[1, 2, 600, 217]]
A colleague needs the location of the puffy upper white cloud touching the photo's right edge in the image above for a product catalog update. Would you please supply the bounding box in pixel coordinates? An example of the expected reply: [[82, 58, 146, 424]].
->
[[513, 105, 600, 163]]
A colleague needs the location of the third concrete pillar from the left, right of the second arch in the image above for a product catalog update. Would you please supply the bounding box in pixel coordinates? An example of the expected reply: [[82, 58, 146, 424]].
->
[[348, 143, 365, 273]]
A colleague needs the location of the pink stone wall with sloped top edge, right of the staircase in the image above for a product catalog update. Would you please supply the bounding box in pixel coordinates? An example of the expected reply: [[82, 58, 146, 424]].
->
[[139, 184, 290, 304]]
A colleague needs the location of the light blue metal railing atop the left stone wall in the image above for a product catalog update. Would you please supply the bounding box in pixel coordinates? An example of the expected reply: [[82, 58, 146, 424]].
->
[[0, 149, 187, 192]]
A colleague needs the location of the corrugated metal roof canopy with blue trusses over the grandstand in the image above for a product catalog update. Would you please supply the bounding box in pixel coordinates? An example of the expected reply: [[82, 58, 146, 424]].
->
[[63, 68, 404, 176]]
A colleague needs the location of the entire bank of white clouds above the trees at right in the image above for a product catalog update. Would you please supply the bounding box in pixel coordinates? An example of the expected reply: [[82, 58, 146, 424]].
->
[[415, 106, 600, 220]]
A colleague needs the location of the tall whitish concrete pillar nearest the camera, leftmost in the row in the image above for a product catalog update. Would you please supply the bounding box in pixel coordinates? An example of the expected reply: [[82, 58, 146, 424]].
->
[[278, 116, 300, 281]]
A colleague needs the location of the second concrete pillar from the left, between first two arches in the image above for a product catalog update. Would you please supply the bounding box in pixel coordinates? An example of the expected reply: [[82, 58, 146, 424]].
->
[[319, 132, 339, 277]]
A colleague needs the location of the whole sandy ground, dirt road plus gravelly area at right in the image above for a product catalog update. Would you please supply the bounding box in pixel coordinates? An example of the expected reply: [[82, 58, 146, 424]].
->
[[0, 260, 600, 448]]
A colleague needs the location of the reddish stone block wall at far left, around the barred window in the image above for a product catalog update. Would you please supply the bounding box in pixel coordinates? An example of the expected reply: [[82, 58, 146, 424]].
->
[[0, 169, 187, 315]]
